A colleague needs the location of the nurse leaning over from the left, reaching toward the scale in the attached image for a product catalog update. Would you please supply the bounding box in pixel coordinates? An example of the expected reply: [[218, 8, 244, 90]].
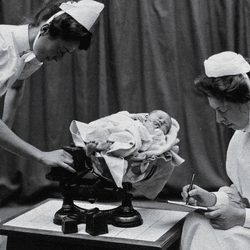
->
[[0, 0, 104, 172]]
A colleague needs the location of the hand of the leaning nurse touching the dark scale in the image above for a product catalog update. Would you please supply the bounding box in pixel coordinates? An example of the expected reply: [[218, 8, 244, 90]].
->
[[40, 149, 76, 173]]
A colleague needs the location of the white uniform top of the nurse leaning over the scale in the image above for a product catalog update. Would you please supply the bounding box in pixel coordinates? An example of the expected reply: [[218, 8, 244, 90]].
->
[[0, 25, 42, 96]]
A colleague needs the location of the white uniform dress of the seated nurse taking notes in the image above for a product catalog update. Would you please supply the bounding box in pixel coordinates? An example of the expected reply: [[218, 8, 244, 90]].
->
[[181, 125, 250, 250]]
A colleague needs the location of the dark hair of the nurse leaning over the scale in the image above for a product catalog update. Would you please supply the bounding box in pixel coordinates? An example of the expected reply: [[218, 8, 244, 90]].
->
[[30, 1, 92, 50]]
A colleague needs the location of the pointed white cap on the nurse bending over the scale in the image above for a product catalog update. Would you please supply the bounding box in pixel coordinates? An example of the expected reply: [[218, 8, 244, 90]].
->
[[60, 0, 104, 30]]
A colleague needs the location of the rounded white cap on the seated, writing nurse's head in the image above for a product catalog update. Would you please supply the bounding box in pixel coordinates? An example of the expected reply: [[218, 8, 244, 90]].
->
[[204, 51, 250, 77]]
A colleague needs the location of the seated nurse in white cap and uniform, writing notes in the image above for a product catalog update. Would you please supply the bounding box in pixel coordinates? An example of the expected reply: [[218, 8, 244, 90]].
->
[[181, 51, 250, 250]]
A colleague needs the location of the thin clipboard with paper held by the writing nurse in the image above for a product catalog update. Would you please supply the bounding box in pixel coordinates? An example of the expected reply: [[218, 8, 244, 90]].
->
[[157, 200, 209, 213]]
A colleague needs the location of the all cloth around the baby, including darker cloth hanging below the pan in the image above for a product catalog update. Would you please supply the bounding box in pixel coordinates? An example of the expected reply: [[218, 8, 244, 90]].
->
[[70, 111, 184, 199]]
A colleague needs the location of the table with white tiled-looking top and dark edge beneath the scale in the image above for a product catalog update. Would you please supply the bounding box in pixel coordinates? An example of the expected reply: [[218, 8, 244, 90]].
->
[[0, 199, 187, 250]]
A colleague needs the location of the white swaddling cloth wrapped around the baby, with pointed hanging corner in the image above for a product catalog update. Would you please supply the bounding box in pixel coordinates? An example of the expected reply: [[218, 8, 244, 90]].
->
[[70, 112, 184, 188]]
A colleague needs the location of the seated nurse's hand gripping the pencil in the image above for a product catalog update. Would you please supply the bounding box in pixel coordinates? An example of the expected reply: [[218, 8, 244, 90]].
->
[[181, 185, 216, 207]]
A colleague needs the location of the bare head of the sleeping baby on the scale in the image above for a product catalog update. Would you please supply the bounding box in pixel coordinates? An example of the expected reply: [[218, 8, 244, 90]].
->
[[147, 110, 172, 135]]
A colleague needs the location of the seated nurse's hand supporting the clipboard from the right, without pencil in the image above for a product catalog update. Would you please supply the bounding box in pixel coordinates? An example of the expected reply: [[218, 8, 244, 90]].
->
[[204, 205, 246, 230]]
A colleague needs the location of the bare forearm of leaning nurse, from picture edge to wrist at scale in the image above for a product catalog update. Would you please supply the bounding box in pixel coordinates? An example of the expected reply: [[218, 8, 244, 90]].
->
[[0, 120, 42, 162]]
